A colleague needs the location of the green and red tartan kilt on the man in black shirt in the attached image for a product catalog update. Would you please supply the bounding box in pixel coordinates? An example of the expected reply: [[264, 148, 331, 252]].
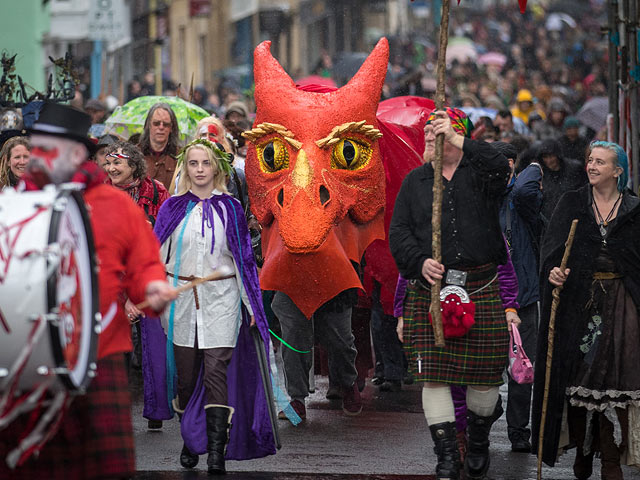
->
[[403, 265, 509, 386]]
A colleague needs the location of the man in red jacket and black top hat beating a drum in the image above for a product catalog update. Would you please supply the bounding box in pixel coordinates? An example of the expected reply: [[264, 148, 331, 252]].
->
[[0, 103, 175, 480]]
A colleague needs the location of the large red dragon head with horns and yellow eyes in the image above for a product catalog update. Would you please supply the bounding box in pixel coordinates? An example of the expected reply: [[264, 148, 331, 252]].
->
[[244, 38, 389, 317]]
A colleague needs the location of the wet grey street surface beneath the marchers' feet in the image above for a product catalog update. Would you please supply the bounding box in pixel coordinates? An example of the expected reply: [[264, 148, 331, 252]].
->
[[132, 366, 640, 480]]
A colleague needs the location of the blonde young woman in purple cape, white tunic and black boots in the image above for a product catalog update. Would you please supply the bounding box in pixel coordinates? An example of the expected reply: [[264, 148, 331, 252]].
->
[[142, 139, 275, 474]]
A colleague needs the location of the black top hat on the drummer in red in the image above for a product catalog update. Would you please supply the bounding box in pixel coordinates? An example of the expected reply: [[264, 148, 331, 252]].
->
[[28, 102, 96, 153]]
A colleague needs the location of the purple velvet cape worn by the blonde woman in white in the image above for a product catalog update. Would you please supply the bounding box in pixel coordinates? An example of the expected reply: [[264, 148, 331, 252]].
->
[[141, 192, 276, 460]]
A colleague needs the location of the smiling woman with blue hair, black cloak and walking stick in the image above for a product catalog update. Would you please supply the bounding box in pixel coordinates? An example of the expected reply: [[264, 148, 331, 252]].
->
[[533, 141, 640, 480]]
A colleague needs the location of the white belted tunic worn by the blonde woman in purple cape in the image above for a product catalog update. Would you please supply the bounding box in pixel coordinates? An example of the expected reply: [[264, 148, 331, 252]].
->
[[160, 190, 253, 349]]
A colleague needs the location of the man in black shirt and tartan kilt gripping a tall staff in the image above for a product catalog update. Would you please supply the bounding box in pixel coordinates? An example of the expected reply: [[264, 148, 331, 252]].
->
[[389, 108, 509, 480]]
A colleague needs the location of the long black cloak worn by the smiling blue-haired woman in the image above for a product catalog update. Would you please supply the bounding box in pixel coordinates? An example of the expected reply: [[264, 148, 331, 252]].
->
[[532, 185, 640, 466]]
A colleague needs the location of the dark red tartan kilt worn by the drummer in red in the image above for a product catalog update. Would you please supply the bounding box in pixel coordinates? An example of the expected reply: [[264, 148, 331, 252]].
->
[[0, 353, 136, 480]]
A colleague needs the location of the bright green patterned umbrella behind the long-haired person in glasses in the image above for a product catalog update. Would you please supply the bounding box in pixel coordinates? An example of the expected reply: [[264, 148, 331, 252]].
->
[[105, 95, 209, 143]]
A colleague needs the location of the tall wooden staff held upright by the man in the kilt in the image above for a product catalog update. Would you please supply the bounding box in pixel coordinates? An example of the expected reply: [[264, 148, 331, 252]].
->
[[430, 0, 449, 347]]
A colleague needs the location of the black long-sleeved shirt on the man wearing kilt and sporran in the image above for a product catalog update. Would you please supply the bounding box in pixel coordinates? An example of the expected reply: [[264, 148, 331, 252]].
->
[[389, 138, 509, 279]]
